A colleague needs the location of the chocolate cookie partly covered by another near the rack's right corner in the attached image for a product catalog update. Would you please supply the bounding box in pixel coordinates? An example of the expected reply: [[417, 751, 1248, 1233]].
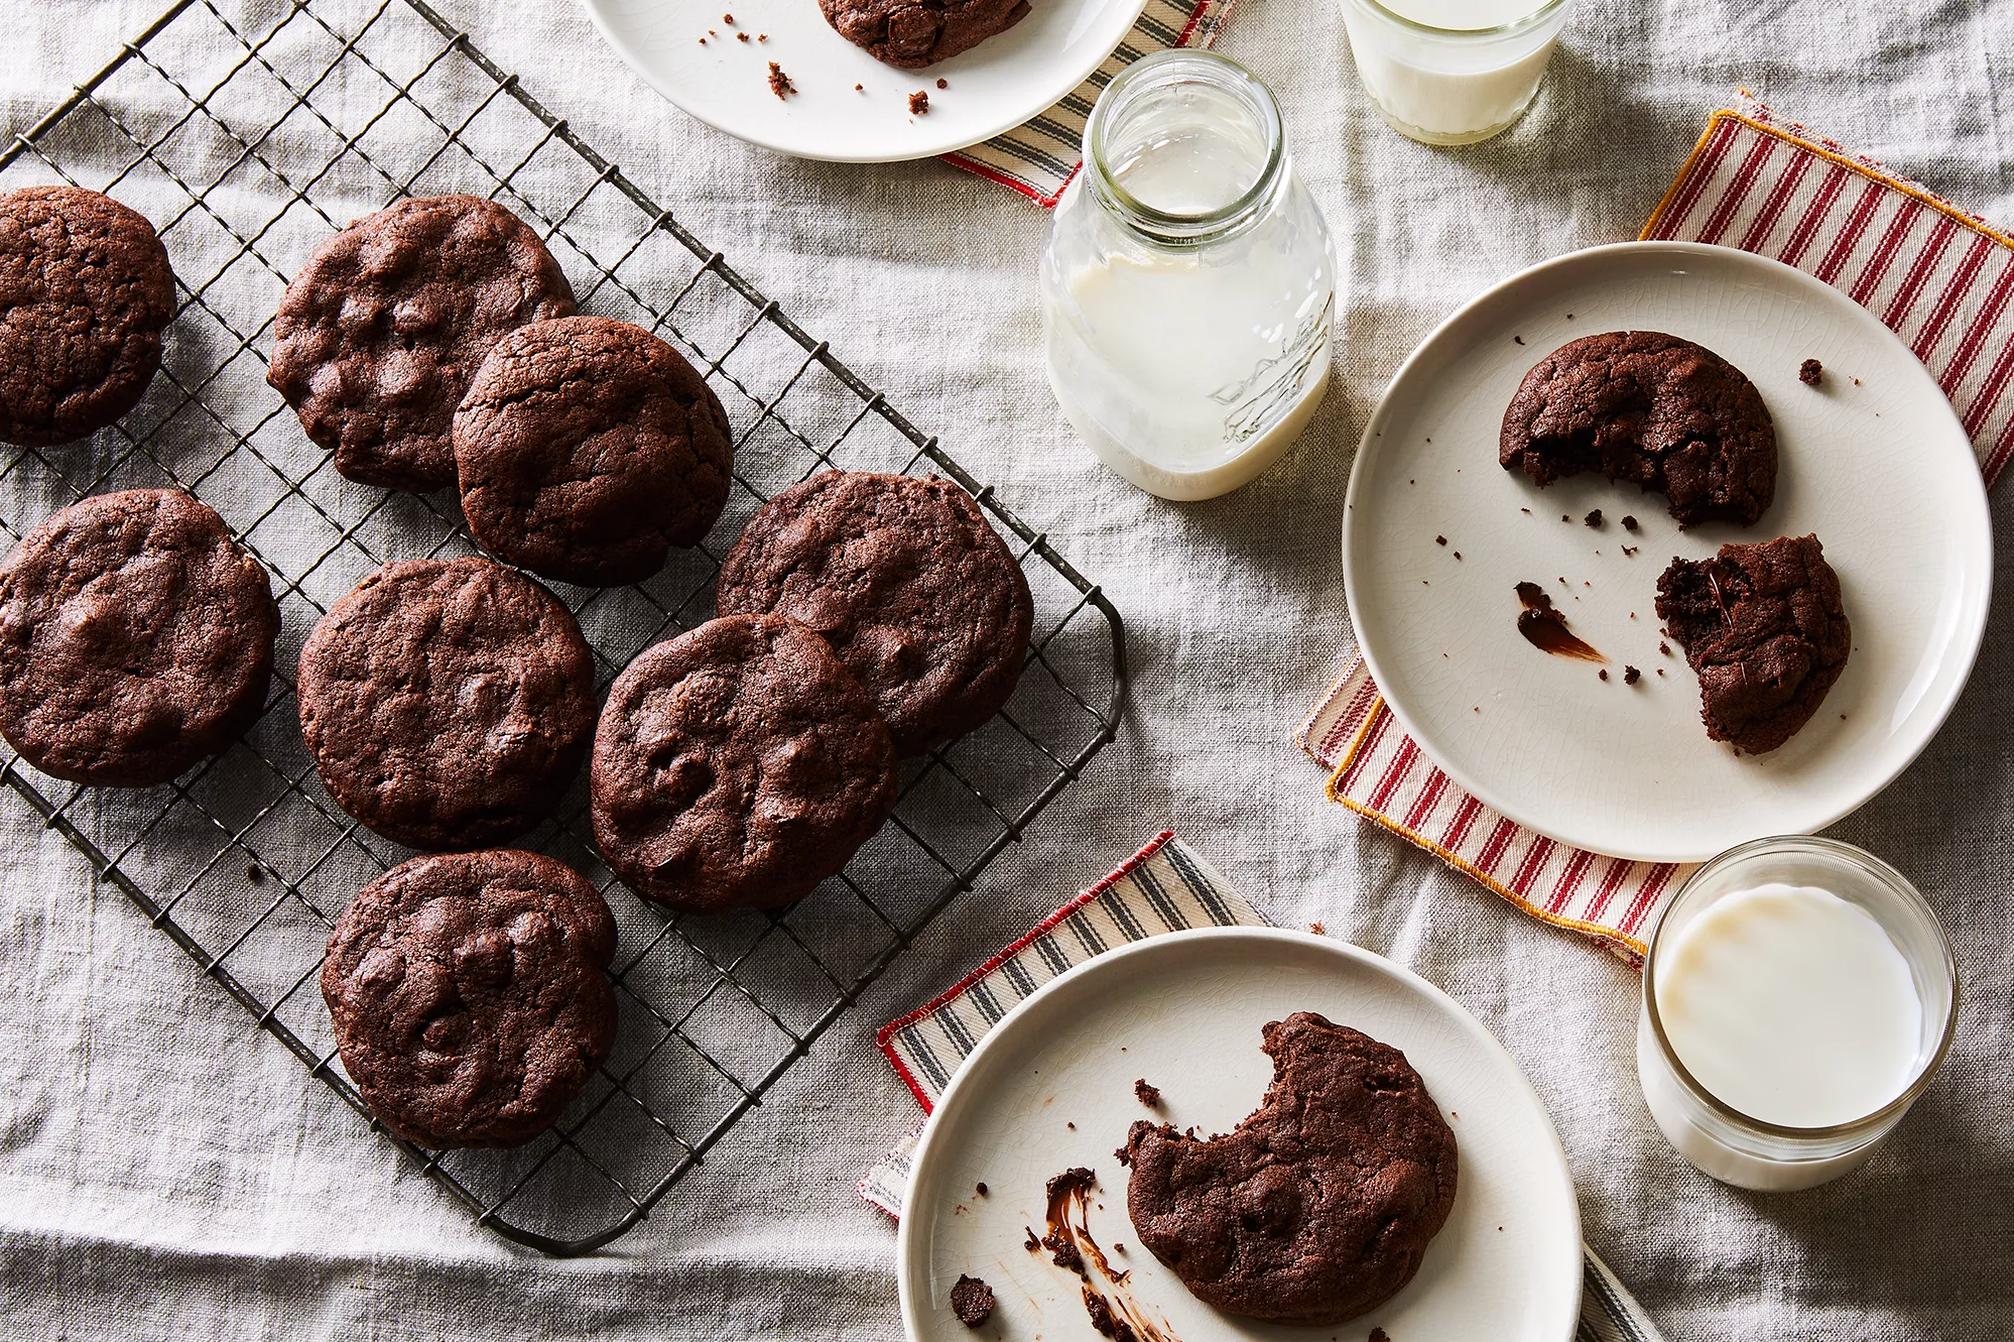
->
[[715, 472, 1035, 756]]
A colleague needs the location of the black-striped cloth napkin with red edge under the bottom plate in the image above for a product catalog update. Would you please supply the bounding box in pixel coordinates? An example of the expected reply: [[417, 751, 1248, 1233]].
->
[[858, 830, 1662, 1342]]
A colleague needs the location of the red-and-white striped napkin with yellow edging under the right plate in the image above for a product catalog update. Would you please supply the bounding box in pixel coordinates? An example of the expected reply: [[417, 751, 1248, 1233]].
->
[[1297, 101, 2014, 963]]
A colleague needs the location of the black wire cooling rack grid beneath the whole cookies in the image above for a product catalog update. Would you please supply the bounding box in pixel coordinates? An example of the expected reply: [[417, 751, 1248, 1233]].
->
[[0, 0, 1126, 1253]]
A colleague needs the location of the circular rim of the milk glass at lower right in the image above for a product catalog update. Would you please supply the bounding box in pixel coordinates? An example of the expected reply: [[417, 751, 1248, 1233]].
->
[[1643, 834, 1958, 1143]]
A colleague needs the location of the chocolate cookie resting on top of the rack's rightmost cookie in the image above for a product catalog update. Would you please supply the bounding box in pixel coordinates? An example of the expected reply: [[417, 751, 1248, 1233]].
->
[[590, 615, 896, 913]]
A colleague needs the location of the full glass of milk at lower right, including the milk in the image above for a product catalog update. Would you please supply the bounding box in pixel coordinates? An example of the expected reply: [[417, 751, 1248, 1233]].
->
[[1637, 838, 1958, 1191]]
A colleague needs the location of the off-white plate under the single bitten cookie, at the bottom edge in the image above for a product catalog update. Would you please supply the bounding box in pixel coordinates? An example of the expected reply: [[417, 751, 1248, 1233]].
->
[[896, 927, 1581, 1342]]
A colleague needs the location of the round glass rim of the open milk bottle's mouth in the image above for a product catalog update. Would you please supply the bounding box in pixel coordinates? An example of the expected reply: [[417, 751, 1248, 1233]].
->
[[1084, 49, 1280, 246]]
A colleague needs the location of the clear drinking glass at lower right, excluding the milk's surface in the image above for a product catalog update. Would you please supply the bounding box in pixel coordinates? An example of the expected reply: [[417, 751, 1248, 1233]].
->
[[1637, 836, 1958, 1191]]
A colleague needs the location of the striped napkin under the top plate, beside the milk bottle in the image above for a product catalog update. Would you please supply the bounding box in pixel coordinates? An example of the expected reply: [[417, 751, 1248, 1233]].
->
[[945, 0, 1237, 210]]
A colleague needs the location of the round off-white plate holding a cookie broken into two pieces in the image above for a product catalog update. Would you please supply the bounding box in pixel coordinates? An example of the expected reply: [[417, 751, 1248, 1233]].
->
[[1343, 242, 1992, 862]]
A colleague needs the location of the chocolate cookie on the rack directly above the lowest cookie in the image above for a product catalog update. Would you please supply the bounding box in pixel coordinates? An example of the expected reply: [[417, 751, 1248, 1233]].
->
[[298, 558, 594, 848]]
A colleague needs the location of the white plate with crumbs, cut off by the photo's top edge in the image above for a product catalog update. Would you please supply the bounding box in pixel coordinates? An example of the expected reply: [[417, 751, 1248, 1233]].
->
[[582, 0, 1146, 163]]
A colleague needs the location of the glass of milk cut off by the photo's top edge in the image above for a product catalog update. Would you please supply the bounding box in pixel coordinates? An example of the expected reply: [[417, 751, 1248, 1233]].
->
[[1341, 0, 1573, 145]]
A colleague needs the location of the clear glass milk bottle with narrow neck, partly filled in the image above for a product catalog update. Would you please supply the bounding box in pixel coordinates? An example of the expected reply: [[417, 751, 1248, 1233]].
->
[[1041, 50, 1335, 500]]
